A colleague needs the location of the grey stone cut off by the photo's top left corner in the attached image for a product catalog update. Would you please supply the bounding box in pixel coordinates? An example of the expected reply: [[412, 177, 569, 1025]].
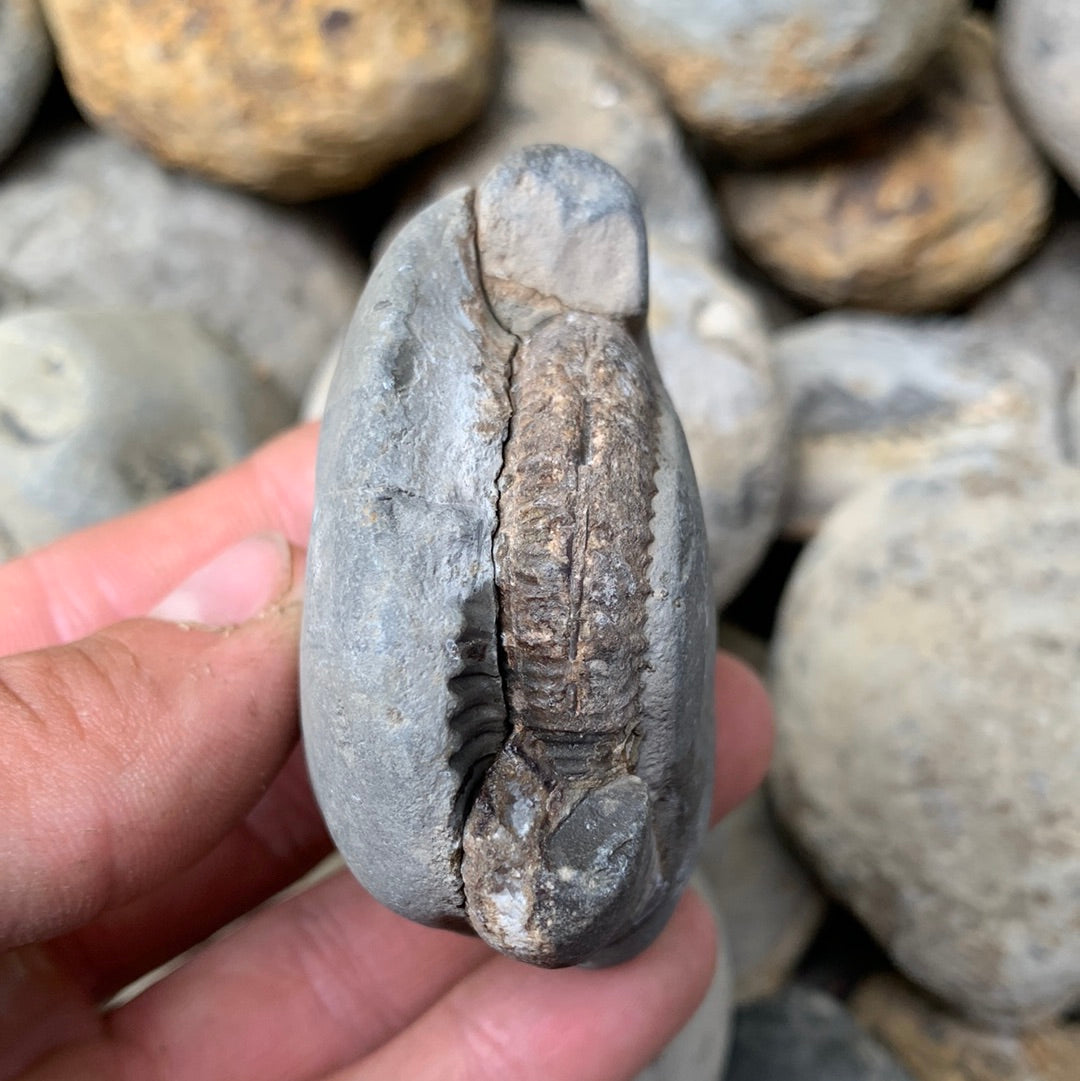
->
[[0, 0, 53, 161]]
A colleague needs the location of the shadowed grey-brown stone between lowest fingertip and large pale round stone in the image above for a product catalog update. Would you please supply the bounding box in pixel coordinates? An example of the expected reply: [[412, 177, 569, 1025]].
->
[[701, 789, 826, 1002]]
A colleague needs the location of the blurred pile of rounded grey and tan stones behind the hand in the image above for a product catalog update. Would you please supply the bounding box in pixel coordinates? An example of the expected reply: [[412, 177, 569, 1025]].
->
[[0, 0, 1080, 1081]]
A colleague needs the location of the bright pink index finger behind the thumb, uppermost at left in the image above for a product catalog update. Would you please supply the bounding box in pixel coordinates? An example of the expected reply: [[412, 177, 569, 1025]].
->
[[0, 425, 318, 654]]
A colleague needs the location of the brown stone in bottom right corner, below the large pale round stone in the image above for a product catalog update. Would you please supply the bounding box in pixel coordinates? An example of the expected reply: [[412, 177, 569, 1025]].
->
[[851, 973, 1080, 1081]]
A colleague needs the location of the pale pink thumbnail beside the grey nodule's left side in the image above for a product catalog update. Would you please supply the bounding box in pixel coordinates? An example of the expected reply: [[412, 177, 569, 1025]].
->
[[149, 533, 292, 627]]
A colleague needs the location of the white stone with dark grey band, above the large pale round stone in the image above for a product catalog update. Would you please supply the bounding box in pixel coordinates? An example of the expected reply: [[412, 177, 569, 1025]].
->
[[774, 311, 1065, 536]]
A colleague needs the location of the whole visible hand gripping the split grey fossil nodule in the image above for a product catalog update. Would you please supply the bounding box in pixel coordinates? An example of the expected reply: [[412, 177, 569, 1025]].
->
[[0, 426, 772, 1081]]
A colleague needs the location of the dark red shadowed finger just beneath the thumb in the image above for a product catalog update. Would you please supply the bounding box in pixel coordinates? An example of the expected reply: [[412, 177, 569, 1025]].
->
[[49, 747, 331, 1002]]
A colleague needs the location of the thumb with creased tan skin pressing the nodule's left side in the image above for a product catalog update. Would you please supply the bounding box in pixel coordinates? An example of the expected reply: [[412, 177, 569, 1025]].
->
[[0, 538, 302, 945]]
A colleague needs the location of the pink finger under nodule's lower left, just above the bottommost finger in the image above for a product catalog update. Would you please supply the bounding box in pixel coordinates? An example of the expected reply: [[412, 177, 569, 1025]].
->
[[23, 872, 492, 1081]]
